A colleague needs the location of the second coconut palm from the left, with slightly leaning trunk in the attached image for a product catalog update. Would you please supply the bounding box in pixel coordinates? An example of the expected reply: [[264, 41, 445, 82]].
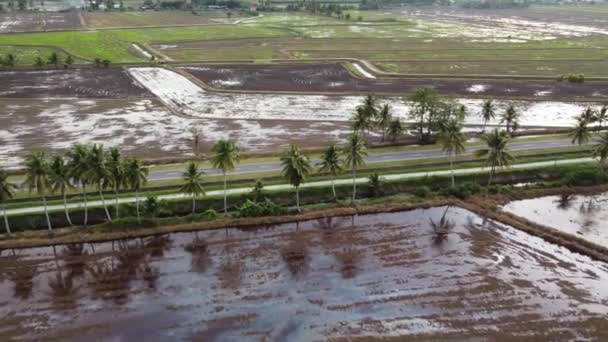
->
[[23, 151, 53, 232]]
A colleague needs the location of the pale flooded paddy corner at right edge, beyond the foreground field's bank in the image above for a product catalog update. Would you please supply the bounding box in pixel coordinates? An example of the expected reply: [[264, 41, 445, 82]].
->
[[503, 193, 608, 247]]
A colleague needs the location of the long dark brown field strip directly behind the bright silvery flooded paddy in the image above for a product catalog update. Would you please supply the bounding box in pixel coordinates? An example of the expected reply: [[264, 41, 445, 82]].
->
[[182, 63, 608, 98]]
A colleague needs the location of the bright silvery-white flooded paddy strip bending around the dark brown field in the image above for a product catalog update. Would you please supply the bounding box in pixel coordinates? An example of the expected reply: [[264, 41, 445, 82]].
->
[[128, 67, 604, 127]]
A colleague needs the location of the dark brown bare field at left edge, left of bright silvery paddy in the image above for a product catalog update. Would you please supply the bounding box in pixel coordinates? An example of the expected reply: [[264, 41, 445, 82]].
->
[[0, 68, 152, 99]]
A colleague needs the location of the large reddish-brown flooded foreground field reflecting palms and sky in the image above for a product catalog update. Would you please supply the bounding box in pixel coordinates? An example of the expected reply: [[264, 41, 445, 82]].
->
[[0, 208, 608, 341]]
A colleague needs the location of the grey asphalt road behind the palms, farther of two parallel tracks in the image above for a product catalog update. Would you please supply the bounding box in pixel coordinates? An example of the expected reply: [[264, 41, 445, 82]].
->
[[148, 139, 572, 181]]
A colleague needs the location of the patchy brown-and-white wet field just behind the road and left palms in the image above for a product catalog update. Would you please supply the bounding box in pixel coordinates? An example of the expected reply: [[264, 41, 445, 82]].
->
[[0, 98, 350, 168]]
